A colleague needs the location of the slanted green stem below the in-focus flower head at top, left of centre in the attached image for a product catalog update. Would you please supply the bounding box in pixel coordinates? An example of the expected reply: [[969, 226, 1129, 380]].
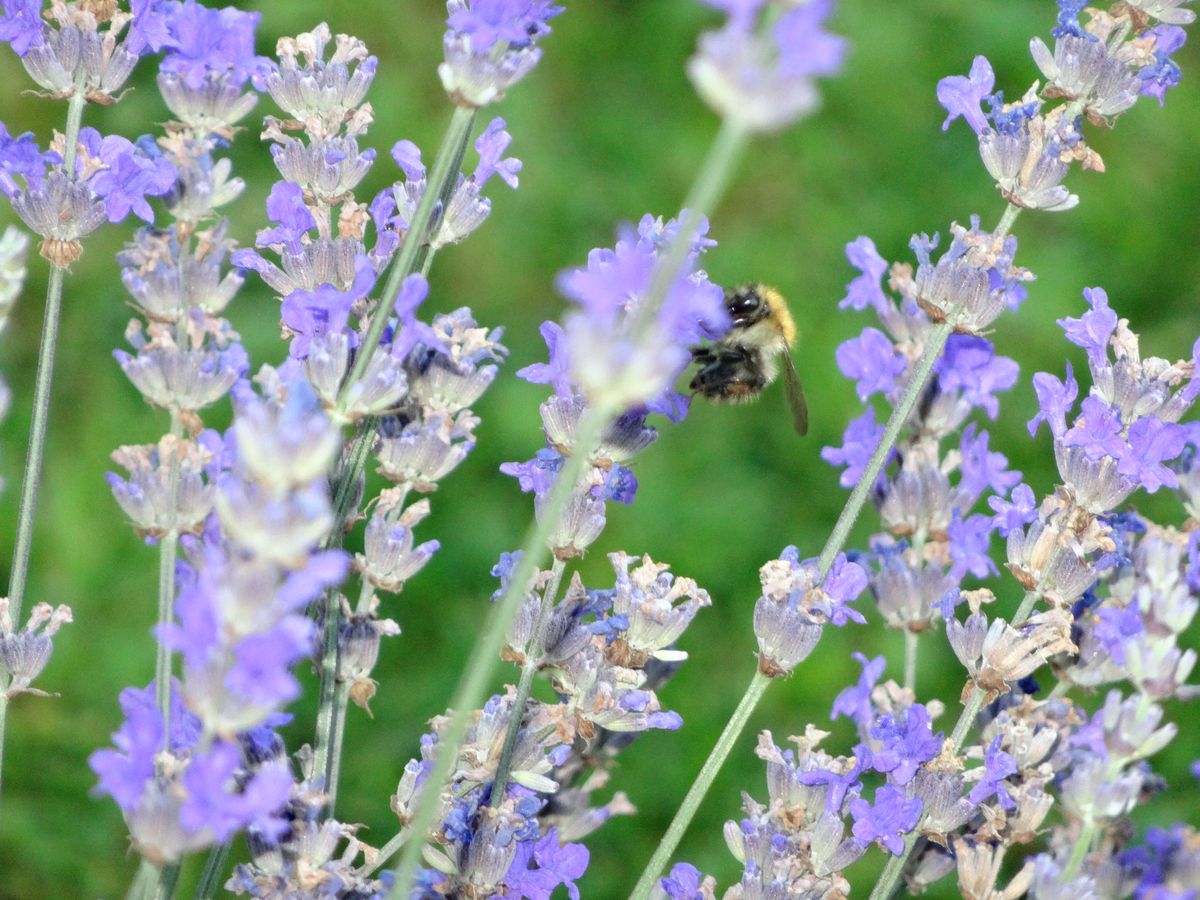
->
[[337, 107, 475, 407]]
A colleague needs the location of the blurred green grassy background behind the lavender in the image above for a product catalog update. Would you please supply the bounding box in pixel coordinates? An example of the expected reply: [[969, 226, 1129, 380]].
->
[[0, 0, 1200, 898]]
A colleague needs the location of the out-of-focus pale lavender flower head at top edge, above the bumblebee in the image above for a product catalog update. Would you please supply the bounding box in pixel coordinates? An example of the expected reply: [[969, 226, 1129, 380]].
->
[[688, 0, 846, 132]]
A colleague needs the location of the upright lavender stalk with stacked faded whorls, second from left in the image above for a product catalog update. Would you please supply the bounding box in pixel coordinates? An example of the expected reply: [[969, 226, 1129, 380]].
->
[[109, 1, 260, 739]]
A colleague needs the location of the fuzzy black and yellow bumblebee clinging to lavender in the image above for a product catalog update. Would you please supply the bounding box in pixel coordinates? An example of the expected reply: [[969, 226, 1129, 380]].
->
[[689, 284, 809, 434]]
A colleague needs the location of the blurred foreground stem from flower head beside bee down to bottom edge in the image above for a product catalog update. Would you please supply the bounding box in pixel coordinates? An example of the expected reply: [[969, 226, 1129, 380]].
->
[[391, 407, 612, 900]]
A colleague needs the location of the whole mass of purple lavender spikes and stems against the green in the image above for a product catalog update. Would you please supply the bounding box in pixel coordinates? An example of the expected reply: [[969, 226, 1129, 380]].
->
[[0, 0, 1200, 900]]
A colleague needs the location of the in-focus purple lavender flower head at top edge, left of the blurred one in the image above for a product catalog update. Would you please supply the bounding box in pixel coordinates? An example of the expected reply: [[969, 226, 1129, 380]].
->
[[438, 0, 563, 108]]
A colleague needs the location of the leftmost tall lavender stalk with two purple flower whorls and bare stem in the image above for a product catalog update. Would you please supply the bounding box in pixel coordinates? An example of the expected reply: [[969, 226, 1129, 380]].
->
[[0, 0, 174, 806]]
